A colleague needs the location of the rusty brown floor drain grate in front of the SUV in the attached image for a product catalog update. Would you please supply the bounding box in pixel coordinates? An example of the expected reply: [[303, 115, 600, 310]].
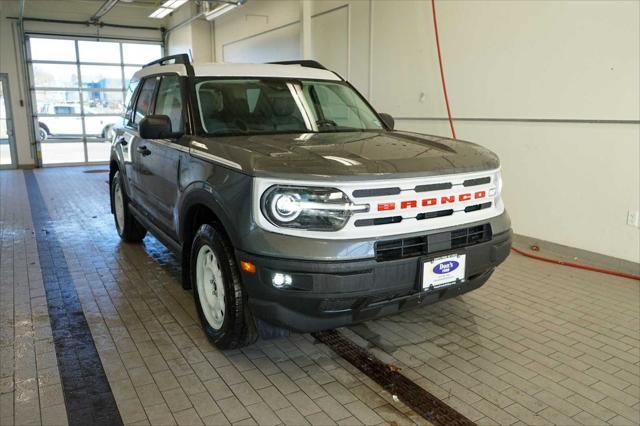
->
[[313, 330, 475, 426]]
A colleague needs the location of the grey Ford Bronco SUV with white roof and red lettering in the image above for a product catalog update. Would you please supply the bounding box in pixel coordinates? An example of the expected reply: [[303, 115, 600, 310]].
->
[[109, 55, 511, 348]]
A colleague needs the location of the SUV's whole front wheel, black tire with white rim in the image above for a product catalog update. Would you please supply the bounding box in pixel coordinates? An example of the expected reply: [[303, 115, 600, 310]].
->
[[190, 224, 256, 349]]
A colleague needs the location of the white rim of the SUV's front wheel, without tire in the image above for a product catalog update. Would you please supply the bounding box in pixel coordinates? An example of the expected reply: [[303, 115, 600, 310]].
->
[[196, 244, 225, 330]]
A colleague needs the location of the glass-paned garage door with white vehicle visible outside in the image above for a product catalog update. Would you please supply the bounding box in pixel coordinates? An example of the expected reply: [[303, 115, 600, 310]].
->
[[27, 35, 162, 164]]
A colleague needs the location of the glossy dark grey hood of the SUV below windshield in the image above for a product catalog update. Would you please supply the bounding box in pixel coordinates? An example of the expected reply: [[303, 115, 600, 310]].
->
[[193, 131, 499, 179]]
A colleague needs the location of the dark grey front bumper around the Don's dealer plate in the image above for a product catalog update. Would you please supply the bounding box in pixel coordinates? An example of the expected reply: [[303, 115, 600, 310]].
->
[[236, 230, 512, 332]]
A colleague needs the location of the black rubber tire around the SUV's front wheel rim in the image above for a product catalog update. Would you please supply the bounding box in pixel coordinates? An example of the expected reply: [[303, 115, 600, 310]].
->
[[189, 224, 257, 349]]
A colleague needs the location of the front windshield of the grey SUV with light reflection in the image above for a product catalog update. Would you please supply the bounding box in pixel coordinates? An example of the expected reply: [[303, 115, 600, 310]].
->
[[196, 79, 383, 135]]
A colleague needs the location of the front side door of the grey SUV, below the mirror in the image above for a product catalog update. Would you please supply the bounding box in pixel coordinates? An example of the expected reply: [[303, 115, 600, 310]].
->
[[135, 75, 188, 238]]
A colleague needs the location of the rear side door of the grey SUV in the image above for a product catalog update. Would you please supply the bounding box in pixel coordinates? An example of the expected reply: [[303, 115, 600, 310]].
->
[[121, 77, 158, 209]]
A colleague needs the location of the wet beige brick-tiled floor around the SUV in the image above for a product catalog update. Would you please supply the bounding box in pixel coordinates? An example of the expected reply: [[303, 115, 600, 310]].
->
[[0, 167, 640, 425]]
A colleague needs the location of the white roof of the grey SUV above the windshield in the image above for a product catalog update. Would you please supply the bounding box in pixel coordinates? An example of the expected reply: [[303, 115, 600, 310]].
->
[[133, 63, 340, 81]]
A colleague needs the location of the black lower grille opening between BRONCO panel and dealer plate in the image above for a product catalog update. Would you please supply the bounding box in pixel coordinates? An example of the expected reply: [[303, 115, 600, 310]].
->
[[375, 224, 491, 262]]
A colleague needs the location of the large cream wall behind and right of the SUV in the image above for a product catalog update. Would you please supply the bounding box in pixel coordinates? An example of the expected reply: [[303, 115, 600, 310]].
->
[[182, 0, 640, 262]]
